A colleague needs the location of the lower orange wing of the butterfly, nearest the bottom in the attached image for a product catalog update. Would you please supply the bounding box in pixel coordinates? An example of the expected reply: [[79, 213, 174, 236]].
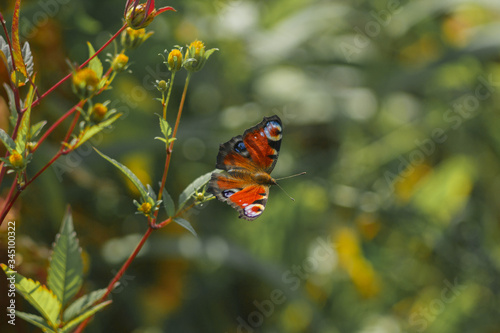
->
[[208, 172, 269, 221]]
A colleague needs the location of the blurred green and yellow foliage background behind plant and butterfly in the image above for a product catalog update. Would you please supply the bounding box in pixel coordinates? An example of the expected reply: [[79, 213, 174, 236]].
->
[[0, 0, 500, 333]]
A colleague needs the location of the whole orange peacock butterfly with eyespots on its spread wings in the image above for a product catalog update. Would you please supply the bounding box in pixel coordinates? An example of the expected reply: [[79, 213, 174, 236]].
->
[[208, 116, 283, 221]]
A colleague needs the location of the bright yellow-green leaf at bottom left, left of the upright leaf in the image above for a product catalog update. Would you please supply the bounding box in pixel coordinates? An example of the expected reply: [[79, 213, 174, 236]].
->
[[0, 264, 61, 327]]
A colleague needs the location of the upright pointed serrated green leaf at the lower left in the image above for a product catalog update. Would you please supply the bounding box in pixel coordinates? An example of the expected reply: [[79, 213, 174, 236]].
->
[[47, 208, 83, 307]]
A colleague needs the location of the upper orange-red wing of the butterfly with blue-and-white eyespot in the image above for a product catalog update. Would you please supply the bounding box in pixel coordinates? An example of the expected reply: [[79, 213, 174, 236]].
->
[[215, 115, 283, 174]]
